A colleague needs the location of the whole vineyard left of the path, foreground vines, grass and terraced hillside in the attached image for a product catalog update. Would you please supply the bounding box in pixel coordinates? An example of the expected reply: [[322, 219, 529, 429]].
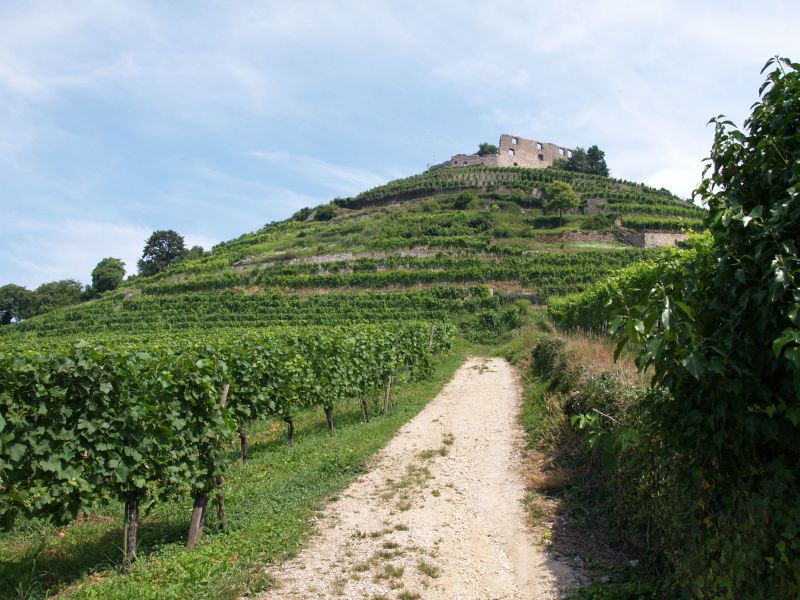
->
[[0, 162, 704, 598]]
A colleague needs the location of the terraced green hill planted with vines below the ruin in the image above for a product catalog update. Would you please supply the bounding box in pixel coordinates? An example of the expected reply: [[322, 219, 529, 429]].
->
[[0, 167, 704, 338]]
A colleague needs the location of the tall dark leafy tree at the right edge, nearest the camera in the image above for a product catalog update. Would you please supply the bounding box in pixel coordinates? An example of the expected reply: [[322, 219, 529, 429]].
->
[[617, 58, 800, 598]]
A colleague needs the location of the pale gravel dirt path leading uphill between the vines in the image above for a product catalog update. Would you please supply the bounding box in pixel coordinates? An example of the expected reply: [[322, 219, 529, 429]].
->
[[261, 359, 577, 600]]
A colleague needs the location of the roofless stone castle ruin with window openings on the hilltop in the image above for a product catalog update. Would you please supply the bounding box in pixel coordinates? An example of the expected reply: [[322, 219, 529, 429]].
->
[[436, 133, 572, 169]]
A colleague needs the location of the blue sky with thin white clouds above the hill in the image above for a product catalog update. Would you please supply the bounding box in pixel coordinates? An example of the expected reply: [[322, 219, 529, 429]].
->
[[0, 0, 800, 289]]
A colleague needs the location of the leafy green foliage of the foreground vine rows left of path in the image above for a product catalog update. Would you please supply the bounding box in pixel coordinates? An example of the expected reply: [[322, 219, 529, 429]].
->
[[0, 323, 452, 564]]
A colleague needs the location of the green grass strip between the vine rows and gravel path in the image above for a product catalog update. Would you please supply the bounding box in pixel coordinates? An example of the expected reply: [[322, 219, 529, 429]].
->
[[0, 342, 466, 600]]
